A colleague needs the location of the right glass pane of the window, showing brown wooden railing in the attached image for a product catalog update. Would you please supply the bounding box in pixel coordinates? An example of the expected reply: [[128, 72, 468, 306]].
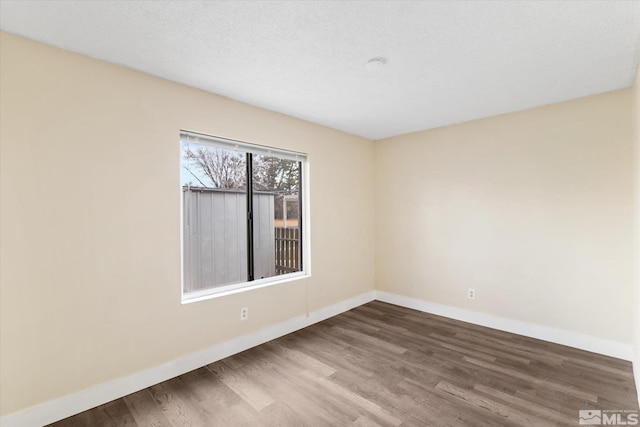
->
[[253, 155, 302, 279]]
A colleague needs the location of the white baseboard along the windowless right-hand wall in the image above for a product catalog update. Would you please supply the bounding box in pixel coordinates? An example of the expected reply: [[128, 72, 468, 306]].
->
[[376, 291, 638, 362]]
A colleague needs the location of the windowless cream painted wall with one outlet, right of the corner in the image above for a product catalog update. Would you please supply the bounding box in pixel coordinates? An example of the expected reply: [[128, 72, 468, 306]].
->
[[376, 90, 633, 344]]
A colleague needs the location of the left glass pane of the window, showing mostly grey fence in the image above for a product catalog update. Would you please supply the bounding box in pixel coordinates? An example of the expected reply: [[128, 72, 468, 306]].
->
[[181, 141, 247, 293]]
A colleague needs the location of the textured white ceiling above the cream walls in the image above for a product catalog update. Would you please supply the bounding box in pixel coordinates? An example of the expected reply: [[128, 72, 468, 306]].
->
[[0, 0, 640, 139]]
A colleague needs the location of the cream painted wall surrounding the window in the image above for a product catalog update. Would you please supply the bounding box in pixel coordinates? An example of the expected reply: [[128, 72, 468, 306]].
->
[[0, 33, 374, 415]]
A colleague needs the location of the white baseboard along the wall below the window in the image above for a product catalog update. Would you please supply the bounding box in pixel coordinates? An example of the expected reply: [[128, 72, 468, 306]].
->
[[0, 291, 376, 427]]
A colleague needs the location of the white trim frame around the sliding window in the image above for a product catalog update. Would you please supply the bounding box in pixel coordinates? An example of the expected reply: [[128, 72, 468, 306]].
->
[[178, 129, 311, 304]]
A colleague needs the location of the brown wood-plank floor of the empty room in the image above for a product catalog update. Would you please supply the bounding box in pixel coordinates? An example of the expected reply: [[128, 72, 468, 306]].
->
[[47, 301, 638, 427]]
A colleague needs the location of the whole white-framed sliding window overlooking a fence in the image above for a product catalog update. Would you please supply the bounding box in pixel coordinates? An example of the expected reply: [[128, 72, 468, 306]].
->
[[180, 132, 306, 301]]
